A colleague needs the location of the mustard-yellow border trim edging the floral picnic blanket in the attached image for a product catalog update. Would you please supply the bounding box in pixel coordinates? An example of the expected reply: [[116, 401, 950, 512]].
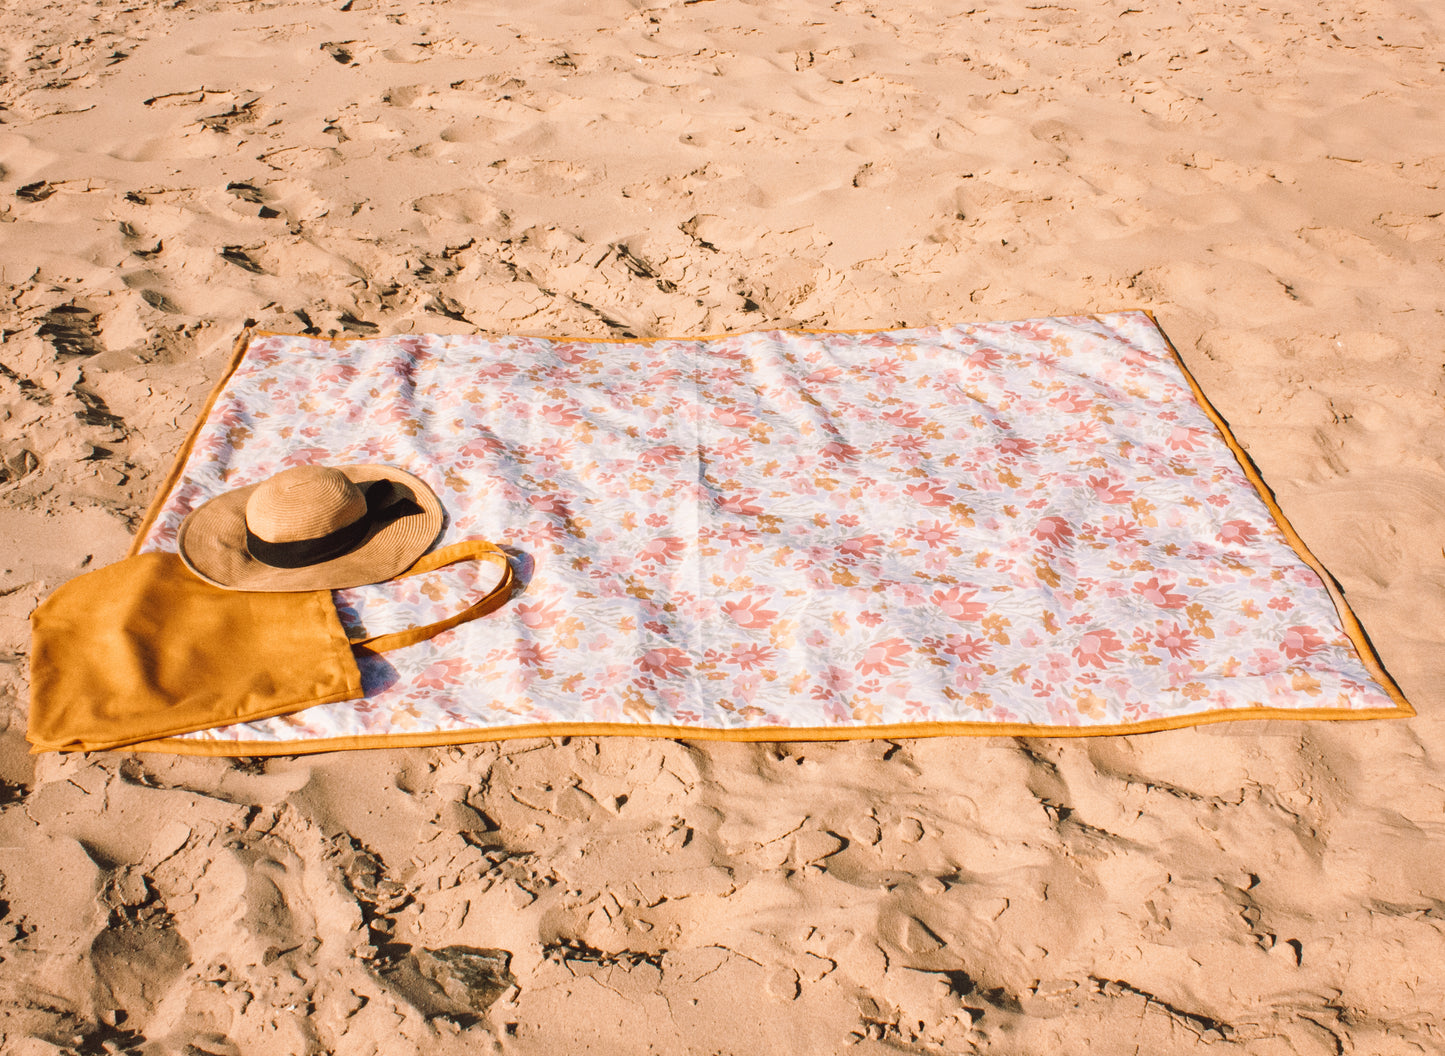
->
[[117, 308, 1416, 756]]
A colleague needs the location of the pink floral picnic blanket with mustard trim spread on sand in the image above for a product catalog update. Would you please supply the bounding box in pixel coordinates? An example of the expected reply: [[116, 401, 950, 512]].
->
[[127, 312, 1413, 754]]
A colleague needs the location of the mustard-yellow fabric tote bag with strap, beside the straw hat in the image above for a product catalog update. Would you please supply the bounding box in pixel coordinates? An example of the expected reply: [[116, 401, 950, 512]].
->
[[26, 540, 514, 751]]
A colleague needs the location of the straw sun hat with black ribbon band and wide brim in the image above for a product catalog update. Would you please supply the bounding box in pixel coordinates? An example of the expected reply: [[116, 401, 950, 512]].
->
[[176, 465, 442, 592]]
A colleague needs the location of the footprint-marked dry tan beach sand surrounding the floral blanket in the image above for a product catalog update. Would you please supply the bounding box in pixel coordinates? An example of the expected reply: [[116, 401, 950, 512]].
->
[[0, 0, 1445, 1056]]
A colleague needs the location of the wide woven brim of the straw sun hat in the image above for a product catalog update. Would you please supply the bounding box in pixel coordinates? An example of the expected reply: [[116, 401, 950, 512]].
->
[[176, 465, 445, 594]]
